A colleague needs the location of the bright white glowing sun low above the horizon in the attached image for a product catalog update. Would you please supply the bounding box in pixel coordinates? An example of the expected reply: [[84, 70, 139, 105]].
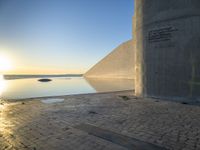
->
[[0, 54, 12, 72]]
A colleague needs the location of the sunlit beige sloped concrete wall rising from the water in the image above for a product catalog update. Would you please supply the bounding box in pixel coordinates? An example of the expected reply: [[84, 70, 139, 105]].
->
[[84, 40, 134, 79]]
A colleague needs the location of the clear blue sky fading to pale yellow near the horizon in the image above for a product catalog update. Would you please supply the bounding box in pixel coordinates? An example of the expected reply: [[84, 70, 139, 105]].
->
[[0, 0, 134, 74]]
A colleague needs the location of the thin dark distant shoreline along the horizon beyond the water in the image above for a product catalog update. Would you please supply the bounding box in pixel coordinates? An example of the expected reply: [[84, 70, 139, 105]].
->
[[3, 74, 83, 80]]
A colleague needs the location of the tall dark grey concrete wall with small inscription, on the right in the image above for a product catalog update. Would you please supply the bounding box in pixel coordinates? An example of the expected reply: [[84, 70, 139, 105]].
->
[[133, 0, 200, 100]]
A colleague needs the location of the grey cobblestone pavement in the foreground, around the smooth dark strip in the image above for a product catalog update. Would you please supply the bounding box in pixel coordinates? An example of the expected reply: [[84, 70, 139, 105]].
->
[[0, 92, 200, 150]]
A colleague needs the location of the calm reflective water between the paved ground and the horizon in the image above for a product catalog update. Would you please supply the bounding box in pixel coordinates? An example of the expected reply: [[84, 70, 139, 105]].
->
[[0, 76, 134, 99]]
